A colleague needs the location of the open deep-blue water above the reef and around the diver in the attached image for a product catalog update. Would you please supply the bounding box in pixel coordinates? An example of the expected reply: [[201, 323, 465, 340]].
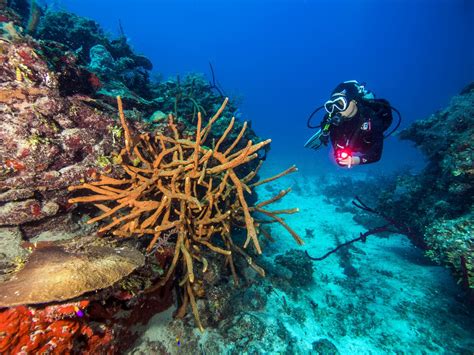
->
[[44, 0, 474, 173]]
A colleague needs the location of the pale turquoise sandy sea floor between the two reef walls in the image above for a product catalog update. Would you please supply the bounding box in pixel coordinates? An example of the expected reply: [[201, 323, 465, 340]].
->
[[130, 160, 474, 354]]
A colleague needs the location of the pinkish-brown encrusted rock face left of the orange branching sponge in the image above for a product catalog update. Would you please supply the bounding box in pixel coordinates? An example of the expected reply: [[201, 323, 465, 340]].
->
[[0, 35, 118, 250]]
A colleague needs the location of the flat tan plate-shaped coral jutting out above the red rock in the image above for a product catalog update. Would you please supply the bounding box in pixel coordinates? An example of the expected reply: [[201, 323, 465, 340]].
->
[[0, 239, 145, 308]]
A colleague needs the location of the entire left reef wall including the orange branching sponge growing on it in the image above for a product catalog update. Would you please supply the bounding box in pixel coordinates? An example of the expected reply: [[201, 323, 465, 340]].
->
[[0, 1, 302, 353]]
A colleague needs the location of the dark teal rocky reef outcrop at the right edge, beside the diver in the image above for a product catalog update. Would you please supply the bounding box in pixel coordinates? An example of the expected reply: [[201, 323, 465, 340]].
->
[[380, 84, 474, 290]]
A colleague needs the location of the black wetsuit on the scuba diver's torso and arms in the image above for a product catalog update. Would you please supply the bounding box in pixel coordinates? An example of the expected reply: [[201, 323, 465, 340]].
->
[[323, 100, 392, 164]]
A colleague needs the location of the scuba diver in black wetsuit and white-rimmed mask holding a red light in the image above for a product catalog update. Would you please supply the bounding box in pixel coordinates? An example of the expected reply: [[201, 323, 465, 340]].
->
[[304, 80, 401, 168]]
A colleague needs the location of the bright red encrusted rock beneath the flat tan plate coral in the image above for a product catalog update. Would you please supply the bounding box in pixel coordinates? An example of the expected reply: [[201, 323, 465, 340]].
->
[[0, 276, 172, 354]]
